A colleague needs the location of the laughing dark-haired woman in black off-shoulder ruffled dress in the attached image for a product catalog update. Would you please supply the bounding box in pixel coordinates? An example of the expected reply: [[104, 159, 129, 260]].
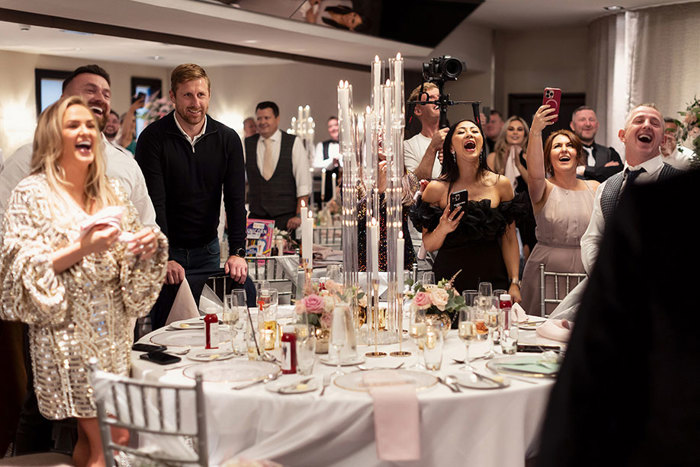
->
[[412, 120, 527, 301]]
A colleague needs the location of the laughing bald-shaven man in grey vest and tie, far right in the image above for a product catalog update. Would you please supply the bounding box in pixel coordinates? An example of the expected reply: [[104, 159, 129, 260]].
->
[[551, 104, 681, 319]]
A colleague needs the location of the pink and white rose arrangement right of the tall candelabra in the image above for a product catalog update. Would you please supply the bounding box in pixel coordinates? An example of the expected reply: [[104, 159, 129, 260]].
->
[[406, 272, 465, 331]]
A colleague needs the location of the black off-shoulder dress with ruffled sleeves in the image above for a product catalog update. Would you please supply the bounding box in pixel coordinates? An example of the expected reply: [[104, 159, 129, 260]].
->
[[411, 195, 527, 293]]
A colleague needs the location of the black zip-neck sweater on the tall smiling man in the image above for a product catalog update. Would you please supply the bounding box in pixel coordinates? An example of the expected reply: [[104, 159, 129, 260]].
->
[[136, 113, 246, 254]]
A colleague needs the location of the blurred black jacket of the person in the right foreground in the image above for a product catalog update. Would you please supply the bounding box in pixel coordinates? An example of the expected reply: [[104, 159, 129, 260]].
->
[[538, 172, 700, 467]]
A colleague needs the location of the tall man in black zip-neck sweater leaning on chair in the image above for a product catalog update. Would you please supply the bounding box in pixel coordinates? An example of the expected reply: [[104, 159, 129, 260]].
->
[[136, 64, 248, 314]]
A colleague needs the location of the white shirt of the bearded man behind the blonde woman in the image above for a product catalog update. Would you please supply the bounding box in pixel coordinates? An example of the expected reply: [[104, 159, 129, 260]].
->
[[0, 138, 156, 226]]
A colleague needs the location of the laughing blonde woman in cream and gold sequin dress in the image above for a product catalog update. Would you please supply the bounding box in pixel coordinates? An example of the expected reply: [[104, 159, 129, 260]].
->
[[0, 97, 167, 466]]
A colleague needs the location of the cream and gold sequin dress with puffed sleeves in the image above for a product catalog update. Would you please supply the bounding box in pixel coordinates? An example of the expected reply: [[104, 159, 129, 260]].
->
[[0, 175, 168, 419]]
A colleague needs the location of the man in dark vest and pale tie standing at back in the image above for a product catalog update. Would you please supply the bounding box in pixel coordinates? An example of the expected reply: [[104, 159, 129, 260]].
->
[[244, 101, 311, 233]]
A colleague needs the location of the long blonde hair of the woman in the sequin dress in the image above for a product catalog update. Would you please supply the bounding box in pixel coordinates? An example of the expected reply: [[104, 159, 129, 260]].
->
[[31, 96, 121, 216]]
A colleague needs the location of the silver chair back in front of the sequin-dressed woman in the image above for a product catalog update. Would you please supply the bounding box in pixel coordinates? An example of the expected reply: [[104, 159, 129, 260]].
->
[[91, 359, 208, 466]]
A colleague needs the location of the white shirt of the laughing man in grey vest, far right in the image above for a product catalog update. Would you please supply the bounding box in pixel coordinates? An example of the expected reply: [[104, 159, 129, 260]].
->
[[581, 155, 664, 275]]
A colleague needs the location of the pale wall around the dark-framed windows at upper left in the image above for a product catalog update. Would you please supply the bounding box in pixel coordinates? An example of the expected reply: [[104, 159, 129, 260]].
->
[[0, 51, 170, 159]]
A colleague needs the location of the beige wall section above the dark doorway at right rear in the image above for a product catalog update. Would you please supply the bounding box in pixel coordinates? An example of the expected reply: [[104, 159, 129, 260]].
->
[[494, 27, 588, 115]]
